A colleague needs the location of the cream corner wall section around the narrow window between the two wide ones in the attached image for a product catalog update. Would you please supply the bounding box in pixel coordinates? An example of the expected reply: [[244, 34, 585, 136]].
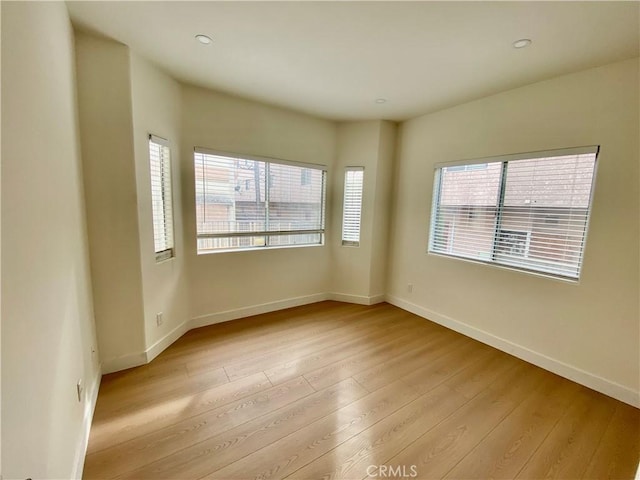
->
[[331, 121, 395, 304]]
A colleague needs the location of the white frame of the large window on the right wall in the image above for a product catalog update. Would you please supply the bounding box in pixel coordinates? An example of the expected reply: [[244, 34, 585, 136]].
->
[[427, 145, 600, 283]]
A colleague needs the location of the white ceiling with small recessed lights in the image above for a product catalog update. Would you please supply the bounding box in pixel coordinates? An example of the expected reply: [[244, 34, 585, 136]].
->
[[67, 1, 640, 120]]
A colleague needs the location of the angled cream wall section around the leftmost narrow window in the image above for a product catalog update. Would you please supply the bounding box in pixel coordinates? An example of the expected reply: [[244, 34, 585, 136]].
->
[[130, 53, 189, 353]]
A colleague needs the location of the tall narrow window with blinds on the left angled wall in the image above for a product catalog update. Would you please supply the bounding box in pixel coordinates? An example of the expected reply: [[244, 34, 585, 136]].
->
[[149, 135, 174, 262]]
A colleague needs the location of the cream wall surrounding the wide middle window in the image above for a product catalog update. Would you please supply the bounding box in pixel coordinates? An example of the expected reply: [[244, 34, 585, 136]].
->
[[181, 86, 336, 322]]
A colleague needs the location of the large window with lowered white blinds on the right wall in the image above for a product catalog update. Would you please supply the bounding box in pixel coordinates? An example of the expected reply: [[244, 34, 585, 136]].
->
[[429, 146, 598, 280]]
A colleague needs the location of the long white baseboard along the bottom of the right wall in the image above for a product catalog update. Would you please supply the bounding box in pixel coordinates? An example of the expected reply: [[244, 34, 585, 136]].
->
[[386, 295, 640, 408]]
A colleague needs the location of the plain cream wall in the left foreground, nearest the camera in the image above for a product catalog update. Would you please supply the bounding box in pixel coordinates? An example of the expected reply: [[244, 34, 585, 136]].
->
[[2, 2, 99, 478]]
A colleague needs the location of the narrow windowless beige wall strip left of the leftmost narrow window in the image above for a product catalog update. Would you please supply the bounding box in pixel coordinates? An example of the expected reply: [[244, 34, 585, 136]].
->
[[76, 33, 145, 372]]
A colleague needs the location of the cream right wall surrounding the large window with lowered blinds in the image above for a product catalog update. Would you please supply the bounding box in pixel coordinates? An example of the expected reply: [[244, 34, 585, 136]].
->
[[388, 60, 640, 404]]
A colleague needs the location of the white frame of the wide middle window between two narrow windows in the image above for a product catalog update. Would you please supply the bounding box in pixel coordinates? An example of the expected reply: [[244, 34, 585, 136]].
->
[[193, 147, 328, 255]]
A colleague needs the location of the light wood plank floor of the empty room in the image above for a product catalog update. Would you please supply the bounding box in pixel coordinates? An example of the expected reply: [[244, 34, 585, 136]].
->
[[84, 302, 640, 479]]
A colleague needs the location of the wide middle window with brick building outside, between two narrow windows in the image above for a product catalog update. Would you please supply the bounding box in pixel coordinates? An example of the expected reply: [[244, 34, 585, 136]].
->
[[194, 149, 326, 253]]
